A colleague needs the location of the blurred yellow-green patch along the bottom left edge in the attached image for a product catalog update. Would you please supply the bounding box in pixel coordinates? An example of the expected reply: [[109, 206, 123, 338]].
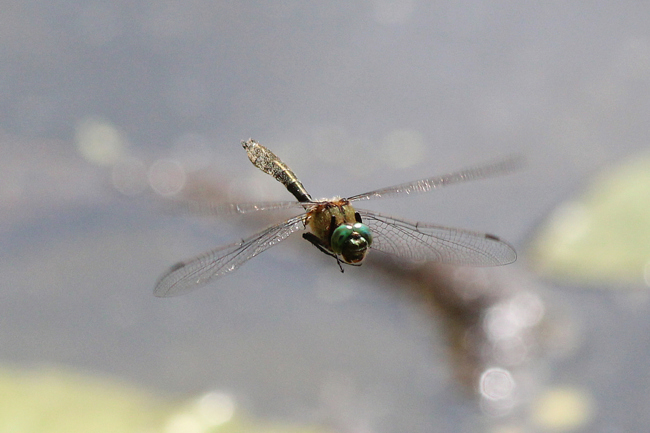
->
[[0, 367, 331, 433]]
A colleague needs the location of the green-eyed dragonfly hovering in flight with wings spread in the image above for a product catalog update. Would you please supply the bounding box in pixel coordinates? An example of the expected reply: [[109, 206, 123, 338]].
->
[[154, 139, 517, 297]]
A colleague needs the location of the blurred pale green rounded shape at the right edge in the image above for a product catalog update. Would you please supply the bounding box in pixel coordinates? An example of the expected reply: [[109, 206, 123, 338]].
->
[[530, 153, 650, 288]]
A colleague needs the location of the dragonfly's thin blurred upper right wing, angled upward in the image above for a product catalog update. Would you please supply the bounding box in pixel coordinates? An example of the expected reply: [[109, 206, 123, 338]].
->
[[348, 156, 523, 201]]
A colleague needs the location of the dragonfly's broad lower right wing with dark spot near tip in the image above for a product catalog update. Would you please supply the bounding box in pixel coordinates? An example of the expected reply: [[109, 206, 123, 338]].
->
[[357, 209, 517, 266]]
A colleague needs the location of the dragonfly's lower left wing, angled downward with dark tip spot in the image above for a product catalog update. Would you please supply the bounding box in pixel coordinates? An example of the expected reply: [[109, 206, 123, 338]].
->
[[154, 214, 305, 297]]
